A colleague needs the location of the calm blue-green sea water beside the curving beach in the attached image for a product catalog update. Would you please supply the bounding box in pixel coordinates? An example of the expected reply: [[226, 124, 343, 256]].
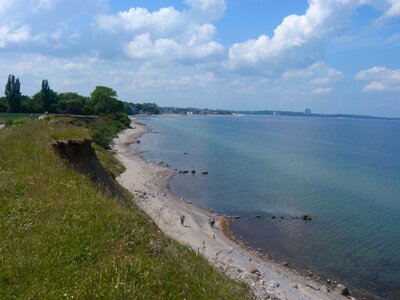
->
[[134, 116, 400, 299]]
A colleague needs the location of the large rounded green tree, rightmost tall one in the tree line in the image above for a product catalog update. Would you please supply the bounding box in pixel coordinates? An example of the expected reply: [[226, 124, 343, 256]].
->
[[85, 86, 124, 115]]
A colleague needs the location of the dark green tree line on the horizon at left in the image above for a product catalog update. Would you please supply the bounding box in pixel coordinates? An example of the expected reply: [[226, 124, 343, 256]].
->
[[0, 75, 160, 115]]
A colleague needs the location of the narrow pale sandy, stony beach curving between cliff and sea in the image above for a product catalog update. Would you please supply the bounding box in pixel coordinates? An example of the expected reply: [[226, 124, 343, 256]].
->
[[113, 120, 344, 299]]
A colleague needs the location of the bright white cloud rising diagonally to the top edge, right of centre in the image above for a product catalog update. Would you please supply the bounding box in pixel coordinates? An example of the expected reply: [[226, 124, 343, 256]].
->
[[228, 0, 358, 71]]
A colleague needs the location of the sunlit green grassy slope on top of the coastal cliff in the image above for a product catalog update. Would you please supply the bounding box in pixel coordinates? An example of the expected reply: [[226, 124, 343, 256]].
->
[[0, 121, 250, 299]]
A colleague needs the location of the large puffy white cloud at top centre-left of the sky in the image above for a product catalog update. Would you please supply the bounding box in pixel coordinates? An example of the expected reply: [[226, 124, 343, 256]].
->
[[96, 0, 225, 64]]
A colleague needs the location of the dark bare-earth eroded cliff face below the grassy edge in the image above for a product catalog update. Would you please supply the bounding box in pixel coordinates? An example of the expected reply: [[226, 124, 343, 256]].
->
[[53, 139, 120, 195]]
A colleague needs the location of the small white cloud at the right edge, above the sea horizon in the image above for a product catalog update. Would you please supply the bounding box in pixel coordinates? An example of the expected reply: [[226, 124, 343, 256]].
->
[[355, 67, 400, 92]]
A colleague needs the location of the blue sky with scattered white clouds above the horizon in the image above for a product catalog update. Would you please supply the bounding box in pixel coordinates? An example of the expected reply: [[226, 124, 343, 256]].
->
[[0, 0, 400, 117]]
